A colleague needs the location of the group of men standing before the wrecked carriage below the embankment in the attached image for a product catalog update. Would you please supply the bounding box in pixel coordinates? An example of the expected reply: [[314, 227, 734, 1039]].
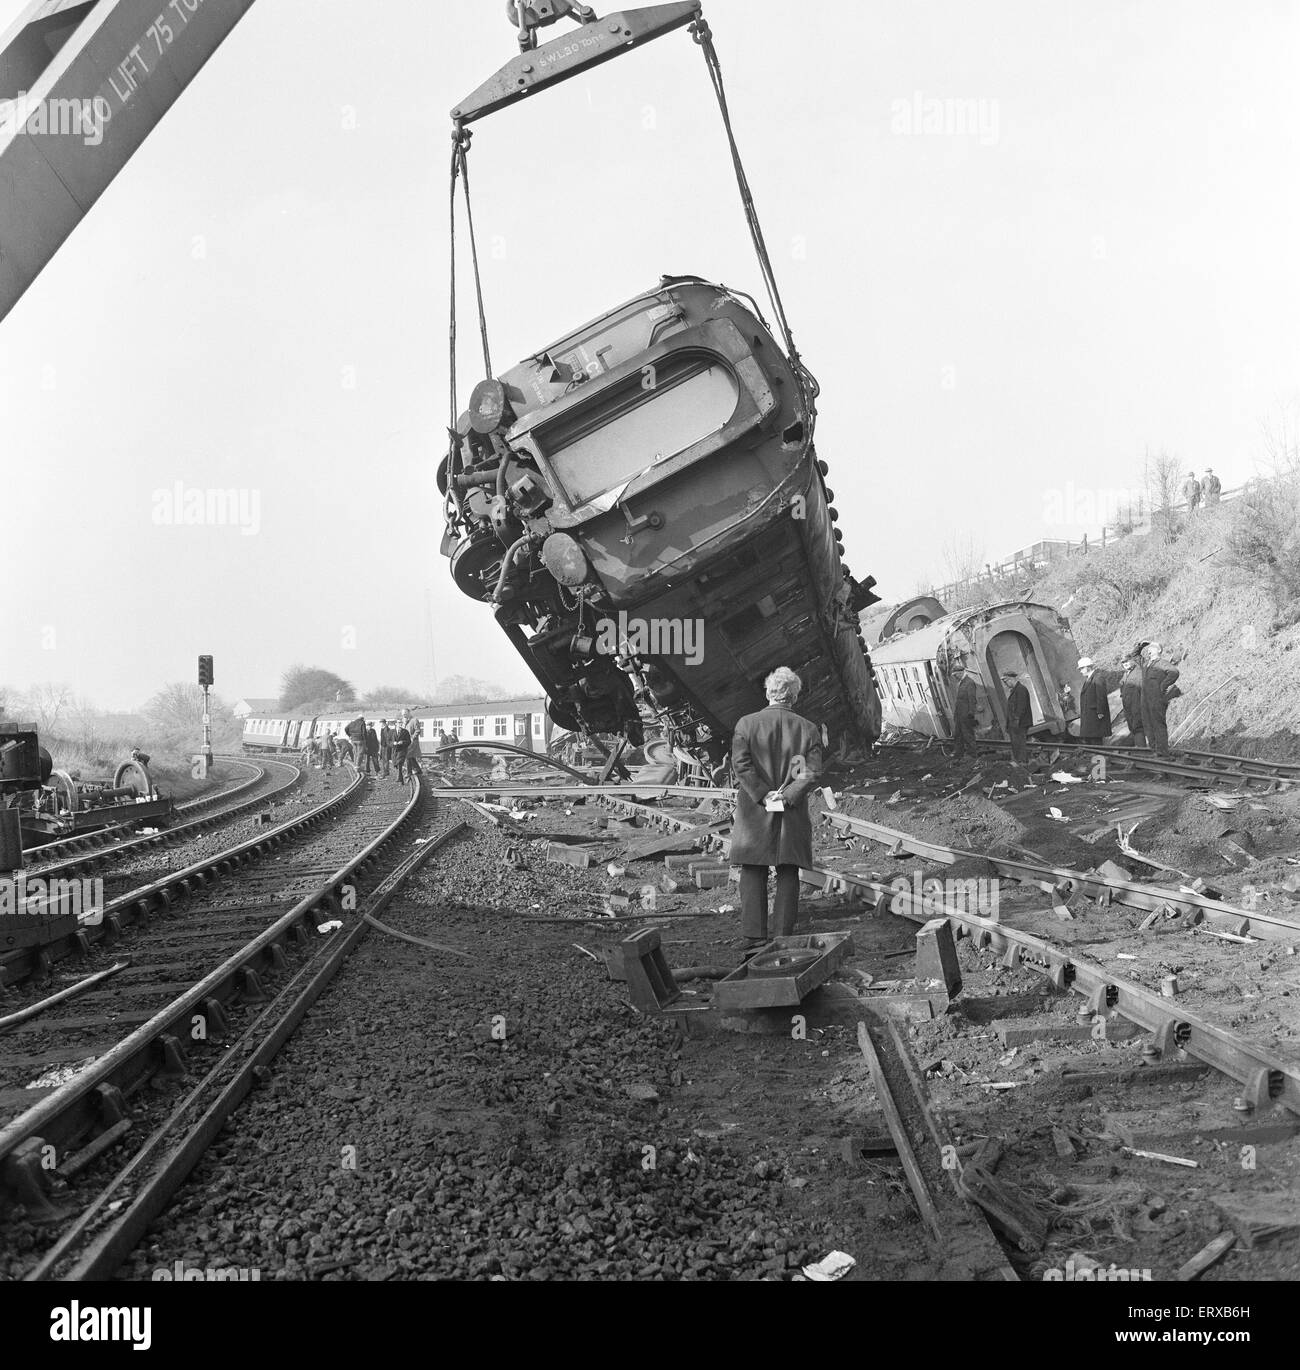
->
[[952, 643, 1182, 766]]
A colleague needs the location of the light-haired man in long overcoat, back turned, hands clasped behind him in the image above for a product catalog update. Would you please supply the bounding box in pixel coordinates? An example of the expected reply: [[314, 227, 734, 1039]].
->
[[732, 666, 822, 948]]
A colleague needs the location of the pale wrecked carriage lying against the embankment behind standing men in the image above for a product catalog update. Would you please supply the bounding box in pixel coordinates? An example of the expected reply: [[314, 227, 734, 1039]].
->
[[871, 601, 1082, 738]]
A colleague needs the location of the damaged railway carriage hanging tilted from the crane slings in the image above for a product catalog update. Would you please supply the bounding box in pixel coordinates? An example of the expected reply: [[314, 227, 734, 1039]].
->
[[440, 277, 881, 764]]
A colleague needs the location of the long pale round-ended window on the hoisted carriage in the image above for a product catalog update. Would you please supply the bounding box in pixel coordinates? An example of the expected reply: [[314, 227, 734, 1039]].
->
[[534, 358, 740, 504]]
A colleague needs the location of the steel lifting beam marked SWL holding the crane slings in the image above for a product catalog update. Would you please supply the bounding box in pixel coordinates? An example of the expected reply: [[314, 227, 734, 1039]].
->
[[452, 0, 701, 125]]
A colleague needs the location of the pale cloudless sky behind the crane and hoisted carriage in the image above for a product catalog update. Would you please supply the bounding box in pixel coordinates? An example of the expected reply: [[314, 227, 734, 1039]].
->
[[0, 0, 1300, 707]]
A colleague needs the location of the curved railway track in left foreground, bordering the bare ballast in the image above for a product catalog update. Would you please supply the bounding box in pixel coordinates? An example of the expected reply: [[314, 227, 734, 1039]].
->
[[0, 780, 464, 1280]]
